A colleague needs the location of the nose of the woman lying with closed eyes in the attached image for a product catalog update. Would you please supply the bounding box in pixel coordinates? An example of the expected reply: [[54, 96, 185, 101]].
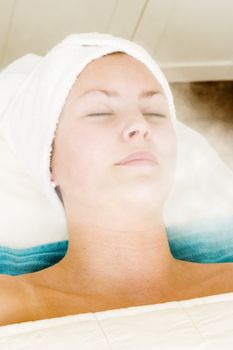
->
[[123, 117, 150, 140]]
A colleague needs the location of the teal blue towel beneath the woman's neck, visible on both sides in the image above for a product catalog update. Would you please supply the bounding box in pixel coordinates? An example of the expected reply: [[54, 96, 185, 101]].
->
[[0, 217, 233, 276]]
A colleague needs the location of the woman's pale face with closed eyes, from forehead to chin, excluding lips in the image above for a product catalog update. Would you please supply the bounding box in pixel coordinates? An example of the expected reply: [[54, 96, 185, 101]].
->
[[51, 53, 176, 211]]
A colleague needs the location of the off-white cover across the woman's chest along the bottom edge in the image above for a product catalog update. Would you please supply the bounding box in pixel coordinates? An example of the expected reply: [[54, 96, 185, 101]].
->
[[0, 293, 233, 350]]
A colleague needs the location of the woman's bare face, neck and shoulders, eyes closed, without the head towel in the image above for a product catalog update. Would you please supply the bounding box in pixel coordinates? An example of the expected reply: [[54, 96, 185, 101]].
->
[[0, 35, 233, 325]]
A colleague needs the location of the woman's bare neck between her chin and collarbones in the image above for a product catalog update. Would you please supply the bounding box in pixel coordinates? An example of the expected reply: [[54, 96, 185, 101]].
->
[[39, 211, 176, 300]]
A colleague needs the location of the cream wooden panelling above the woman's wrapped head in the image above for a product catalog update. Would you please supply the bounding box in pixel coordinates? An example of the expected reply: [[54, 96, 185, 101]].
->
[[0, 0, 233, 82]]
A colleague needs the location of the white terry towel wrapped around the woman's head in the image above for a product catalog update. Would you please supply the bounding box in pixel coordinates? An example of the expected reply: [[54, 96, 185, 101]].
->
[[0, 32, 175, 199]]
